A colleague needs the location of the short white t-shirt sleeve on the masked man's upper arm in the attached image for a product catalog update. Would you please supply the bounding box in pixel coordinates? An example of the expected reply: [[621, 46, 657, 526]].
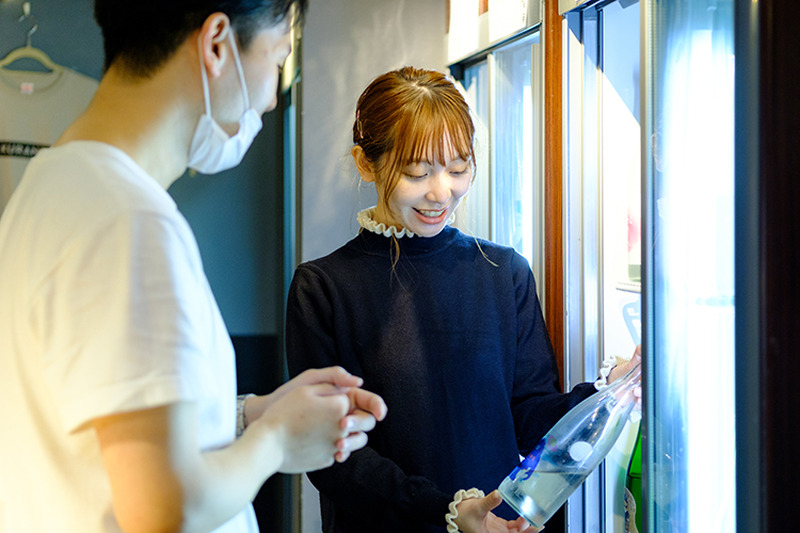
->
[[32, 208, 216, 431]]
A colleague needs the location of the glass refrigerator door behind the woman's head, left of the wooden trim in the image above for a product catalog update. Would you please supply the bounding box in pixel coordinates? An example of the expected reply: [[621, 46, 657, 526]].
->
[[458, 32, 544, 290]]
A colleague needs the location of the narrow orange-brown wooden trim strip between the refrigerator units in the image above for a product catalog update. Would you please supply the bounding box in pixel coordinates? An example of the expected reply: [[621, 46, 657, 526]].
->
[[542, 0, 564, 386]]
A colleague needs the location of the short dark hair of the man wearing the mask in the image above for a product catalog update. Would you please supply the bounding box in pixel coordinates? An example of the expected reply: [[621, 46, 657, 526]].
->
[[94, 0, 308, 77]]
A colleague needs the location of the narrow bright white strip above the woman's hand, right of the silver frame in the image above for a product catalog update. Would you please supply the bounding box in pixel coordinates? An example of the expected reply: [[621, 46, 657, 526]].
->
[[598, 2, 641, 357]]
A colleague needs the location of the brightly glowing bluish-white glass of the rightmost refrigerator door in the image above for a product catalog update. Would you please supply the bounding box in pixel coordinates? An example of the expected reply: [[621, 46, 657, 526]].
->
[[647, 0, 736, 533]]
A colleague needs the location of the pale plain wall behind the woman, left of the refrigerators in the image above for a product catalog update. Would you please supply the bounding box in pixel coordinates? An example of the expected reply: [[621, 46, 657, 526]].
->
[[298, 0, 446, 533]]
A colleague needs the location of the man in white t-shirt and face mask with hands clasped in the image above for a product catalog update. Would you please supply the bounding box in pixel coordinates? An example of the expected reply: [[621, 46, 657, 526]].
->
[[0, 0, 386, 533]]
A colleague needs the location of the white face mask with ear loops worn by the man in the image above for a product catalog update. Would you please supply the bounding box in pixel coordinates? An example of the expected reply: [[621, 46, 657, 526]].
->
[[188, 30, 262, 174]]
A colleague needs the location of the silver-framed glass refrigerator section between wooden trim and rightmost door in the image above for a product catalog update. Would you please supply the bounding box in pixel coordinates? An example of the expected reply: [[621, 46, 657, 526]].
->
[[563, 0, 641, 533]]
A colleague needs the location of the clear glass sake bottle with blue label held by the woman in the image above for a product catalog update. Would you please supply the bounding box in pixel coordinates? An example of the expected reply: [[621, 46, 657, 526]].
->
[[498, 365, 641, 527]]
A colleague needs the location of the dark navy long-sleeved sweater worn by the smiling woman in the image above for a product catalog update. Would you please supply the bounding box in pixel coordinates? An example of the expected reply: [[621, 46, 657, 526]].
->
[[286, 227, 595, 533]]
